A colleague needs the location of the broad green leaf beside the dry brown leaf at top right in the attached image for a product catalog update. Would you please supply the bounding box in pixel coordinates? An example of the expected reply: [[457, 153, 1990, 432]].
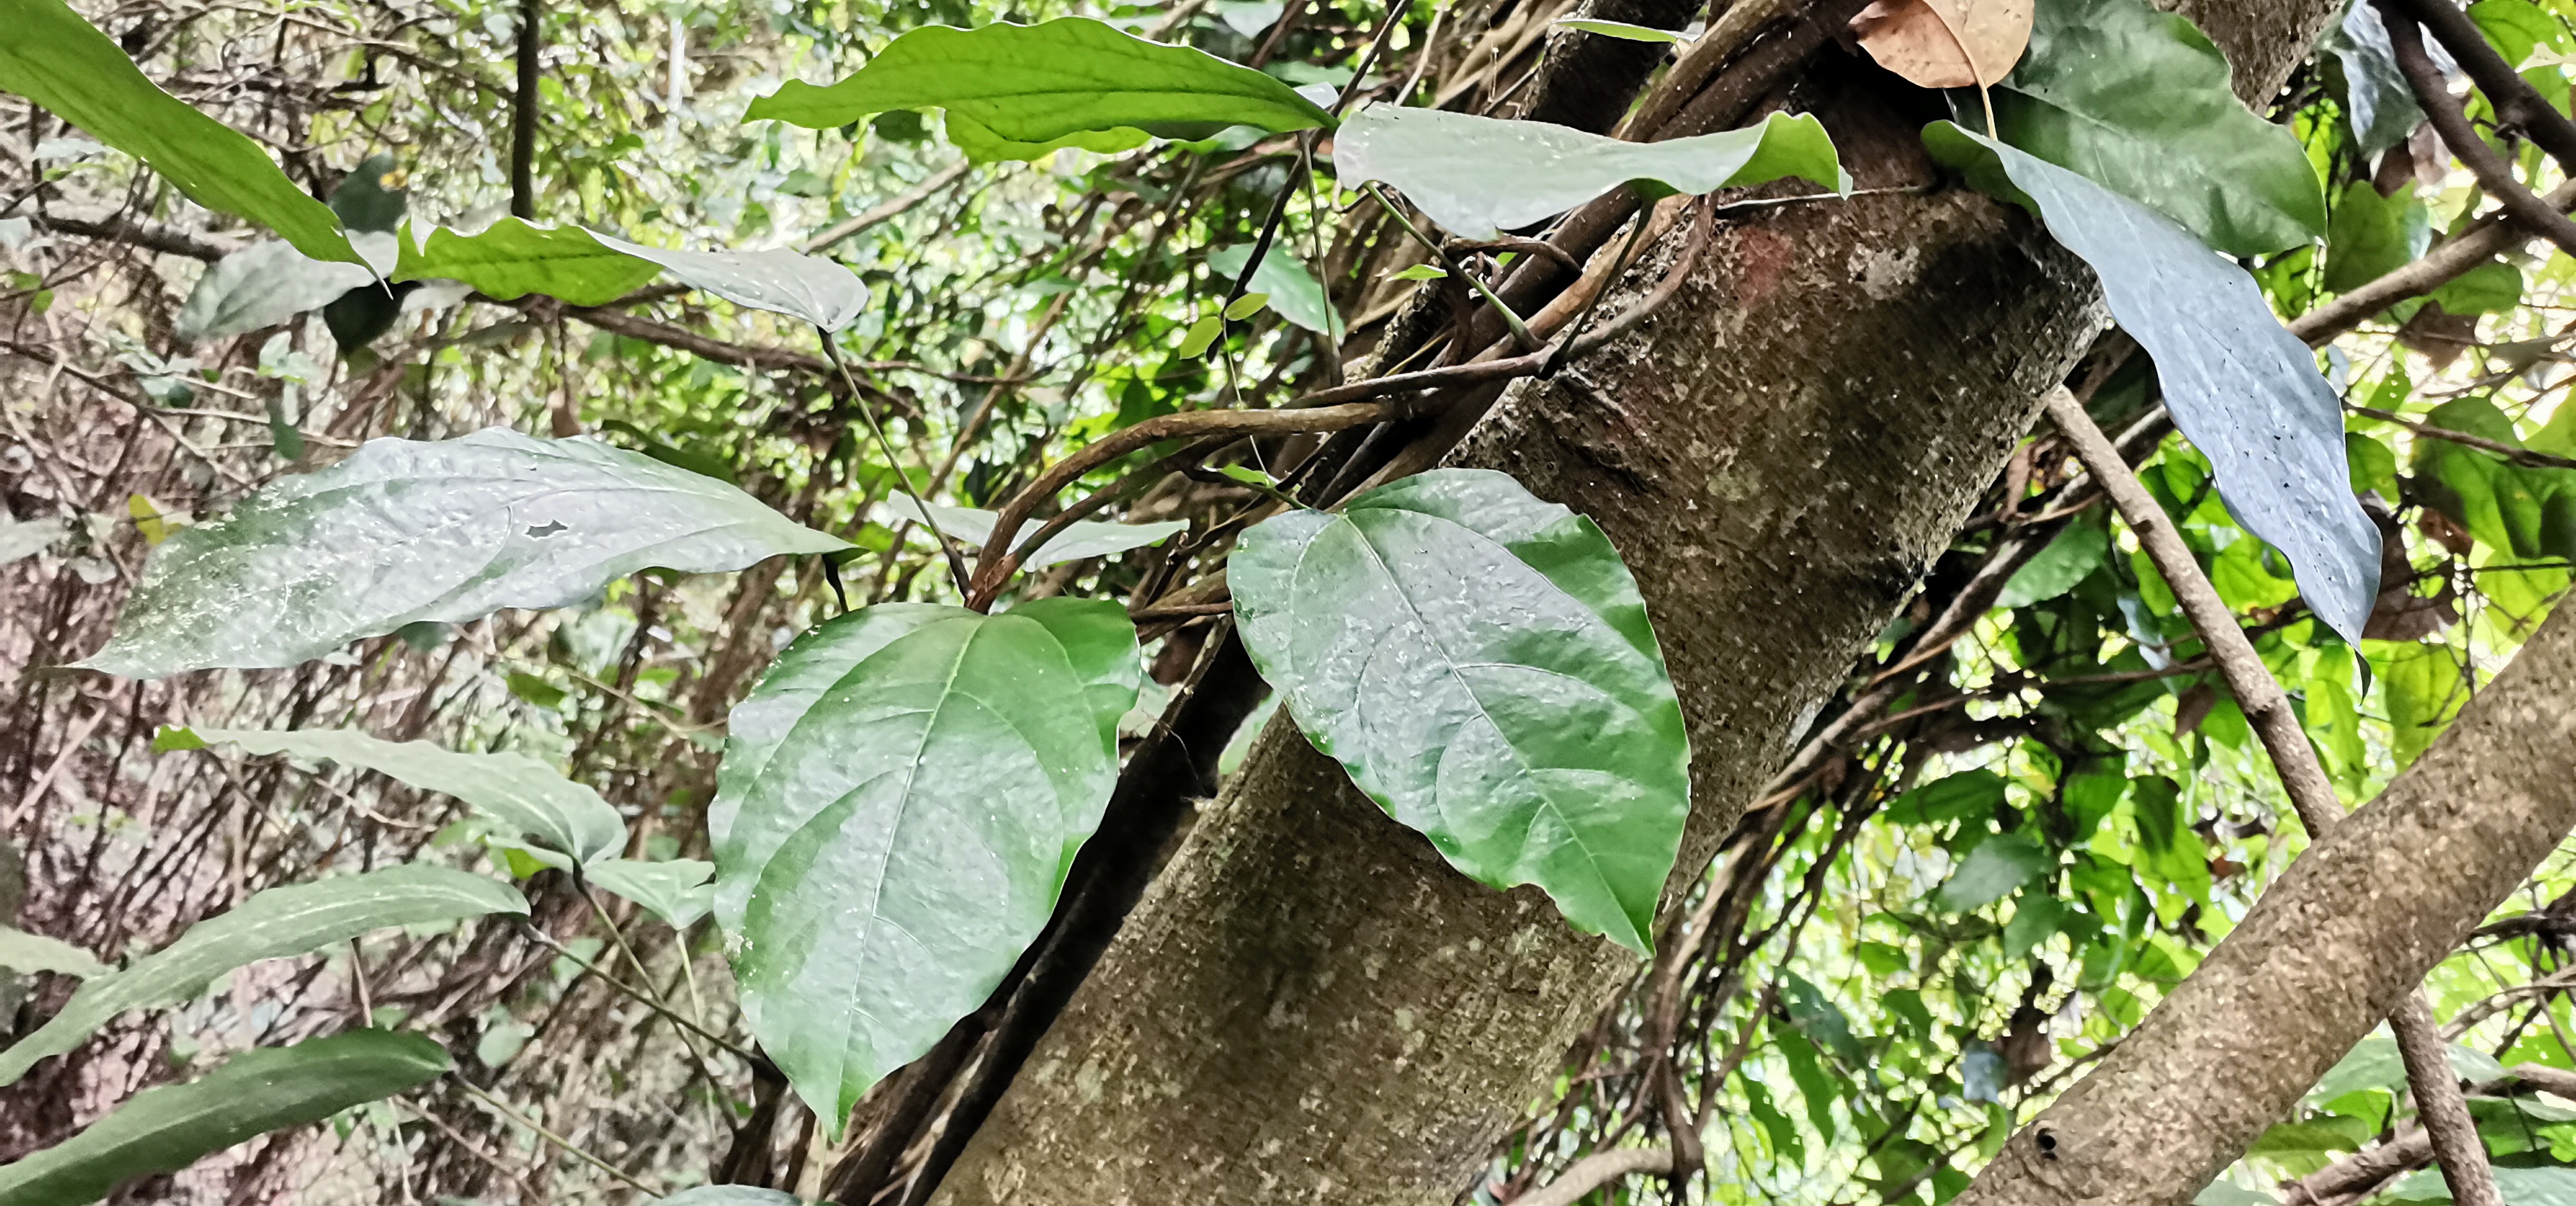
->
[[1994, 0, 2326, 255]]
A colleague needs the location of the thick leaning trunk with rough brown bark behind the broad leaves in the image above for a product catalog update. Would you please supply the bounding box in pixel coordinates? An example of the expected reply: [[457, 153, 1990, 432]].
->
[[935, 0, 2331, 1206]]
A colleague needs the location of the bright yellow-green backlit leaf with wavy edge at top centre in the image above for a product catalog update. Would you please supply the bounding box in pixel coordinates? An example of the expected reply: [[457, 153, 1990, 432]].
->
[[744, 18, 1332, 160]]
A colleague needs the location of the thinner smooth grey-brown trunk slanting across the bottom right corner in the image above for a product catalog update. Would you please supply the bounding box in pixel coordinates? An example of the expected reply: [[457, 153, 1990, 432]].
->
[[1955, 608, 2576, 1206]]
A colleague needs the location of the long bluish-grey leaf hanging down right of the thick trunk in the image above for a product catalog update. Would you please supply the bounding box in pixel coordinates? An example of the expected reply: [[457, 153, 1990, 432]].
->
[[1924, 121, 2380, 642]]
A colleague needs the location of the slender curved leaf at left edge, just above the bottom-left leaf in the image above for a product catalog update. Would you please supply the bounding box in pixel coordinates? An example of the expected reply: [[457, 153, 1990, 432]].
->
[[0, 866, 528, 1085]]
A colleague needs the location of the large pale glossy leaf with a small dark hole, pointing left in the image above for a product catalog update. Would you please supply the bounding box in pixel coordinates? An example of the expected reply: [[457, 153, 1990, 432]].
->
[[80, 428, 848, 678]]
